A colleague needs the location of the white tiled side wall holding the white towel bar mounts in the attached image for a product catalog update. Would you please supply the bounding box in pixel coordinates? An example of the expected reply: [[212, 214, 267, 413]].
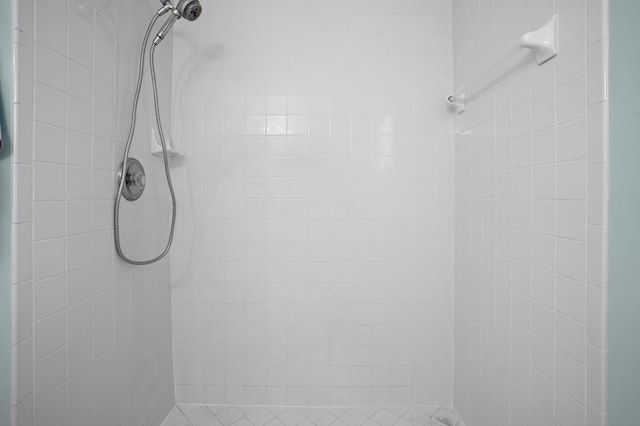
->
[[453, 0, 608, 426]]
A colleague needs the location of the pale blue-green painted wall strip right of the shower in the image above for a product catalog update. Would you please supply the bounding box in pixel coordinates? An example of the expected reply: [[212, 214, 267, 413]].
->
[[609, 0, 640, 426]]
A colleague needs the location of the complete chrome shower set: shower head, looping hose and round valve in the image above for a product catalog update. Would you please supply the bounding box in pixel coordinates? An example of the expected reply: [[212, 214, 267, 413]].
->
[[113, 0, 202, 265]]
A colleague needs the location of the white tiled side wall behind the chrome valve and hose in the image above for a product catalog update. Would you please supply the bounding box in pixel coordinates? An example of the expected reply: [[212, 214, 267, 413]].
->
[[12, 0, 179, 426]]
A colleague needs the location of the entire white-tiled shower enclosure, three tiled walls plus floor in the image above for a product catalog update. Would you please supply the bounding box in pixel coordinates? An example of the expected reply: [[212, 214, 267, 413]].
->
[[12, 0, 608, 426]]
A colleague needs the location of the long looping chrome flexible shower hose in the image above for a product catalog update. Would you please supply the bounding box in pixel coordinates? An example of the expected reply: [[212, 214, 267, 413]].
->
[[113, 13, 176, 265]]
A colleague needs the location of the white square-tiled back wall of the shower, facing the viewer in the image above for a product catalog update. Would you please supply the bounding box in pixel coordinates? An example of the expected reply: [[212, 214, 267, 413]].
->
[[171, 0, 454, 406]]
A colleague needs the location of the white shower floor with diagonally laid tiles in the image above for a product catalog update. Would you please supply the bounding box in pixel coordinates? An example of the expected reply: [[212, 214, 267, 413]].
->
[[162, 404, 464, 426]]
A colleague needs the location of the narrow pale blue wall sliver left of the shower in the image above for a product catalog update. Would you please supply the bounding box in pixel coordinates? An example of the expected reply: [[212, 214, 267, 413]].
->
[[0, 0, 13, 426]]
